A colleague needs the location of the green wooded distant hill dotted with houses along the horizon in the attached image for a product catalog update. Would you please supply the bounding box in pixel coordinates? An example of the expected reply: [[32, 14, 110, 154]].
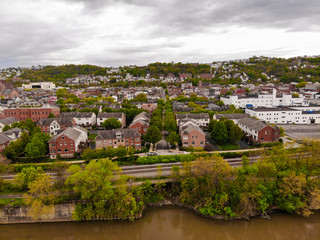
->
[[16, 56, 320, 84]]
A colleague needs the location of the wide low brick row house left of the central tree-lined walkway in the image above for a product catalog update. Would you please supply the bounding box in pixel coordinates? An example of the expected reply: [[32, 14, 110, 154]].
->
[[96, 129, 141, 150]]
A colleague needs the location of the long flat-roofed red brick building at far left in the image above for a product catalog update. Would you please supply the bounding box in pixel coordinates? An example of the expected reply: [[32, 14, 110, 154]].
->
[[4, 107, 60, 122]]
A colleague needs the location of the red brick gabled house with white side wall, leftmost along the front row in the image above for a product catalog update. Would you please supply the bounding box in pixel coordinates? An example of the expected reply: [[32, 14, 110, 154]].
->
[[48, 126, 88, 159]]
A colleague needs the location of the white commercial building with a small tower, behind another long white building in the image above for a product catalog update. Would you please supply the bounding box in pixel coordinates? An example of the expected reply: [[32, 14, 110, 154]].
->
[[220, 89, 307, 108]]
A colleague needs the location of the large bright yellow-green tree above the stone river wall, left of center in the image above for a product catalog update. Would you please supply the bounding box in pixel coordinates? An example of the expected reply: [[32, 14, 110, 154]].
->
[[66, 159, 142, 220]]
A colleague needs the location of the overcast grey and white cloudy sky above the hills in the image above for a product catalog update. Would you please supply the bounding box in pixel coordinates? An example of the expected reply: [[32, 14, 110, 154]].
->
[[0, 0, 320, 68]]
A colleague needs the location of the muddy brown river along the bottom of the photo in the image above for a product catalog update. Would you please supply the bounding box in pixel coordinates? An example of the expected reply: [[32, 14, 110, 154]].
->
[[0, 207, 320, 240]]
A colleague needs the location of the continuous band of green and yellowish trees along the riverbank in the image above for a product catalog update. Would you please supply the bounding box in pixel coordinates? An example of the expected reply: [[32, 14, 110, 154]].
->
[[0, 141, 320, 221]]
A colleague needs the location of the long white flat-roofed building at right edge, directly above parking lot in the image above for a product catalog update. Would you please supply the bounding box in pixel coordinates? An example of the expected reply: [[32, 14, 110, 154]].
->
[[245, 107, 320, 124]]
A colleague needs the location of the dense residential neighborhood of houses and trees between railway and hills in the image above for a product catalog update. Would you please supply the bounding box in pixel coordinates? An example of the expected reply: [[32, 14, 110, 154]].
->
[[0, 57, 320, 159]]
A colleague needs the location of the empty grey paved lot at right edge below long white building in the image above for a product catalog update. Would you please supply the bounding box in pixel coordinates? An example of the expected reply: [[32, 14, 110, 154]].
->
[[278, 124, 320, 140]]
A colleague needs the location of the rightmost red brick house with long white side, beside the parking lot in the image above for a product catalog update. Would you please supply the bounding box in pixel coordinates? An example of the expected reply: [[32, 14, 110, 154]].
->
[[238, 118, 280, 144]]
